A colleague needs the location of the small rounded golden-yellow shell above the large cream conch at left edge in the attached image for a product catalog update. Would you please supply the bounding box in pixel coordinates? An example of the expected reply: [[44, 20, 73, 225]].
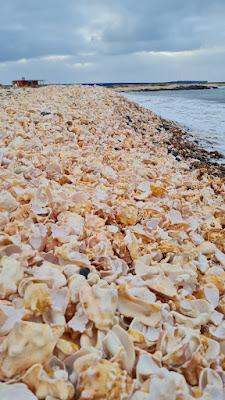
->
[[24, 283, 52, 316]]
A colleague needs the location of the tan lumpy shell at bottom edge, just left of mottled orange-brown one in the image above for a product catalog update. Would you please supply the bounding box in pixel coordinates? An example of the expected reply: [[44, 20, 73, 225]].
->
[[23, 364, 74, 400]]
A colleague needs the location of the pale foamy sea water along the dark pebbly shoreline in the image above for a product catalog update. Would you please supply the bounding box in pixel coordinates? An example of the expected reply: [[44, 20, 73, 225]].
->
[[126, 87, 225, 156]]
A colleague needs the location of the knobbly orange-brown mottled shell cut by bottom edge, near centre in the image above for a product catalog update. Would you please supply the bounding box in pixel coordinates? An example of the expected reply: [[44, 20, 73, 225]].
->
[[74, 360, 133, 400]]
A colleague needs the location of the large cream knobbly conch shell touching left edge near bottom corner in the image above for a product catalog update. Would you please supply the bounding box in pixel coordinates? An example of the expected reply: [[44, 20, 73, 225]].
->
[[0, 321, 62, 378]]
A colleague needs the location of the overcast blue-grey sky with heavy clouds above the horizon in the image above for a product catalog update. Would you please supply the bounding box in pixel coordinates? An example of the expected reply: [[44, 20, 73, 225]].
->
[[0, 0, 225, 83]]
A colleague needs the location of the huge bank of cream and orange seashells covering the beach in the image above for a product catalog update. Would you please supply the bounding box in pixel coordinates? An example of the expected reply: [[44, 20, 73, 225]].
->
[[0, 86, 225, 400]]
